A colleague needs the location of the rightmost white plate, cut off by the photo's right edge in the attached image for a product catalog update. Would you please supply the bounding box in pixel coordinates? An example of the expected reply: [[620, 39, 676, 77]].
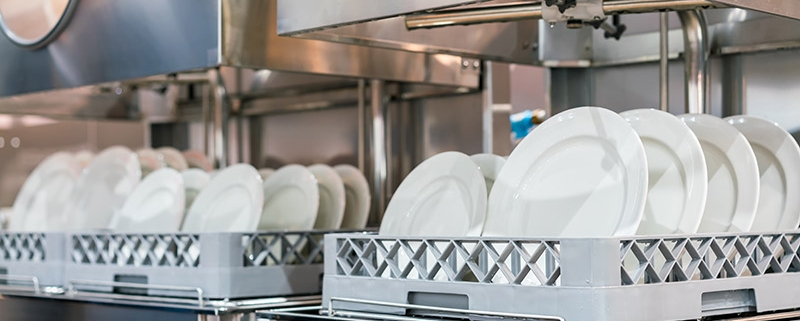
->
[[725, 116, 800, 231]]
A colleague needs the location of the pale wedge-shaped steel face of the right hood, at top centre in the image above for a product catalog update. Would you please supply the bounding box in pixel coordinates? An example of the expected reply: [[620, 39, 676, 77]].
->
[[278, 0, 485, 35]]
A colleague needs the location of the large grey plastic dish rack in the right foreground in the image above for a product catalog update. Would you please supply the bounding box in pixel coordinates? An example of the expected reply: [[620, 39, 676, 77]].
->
[[322, 232, 800, 321]]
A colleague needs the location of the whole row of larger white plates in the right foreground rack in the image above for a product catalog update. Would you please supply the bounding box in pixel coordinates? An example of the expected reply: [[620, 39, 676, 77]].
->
[[380, 107, 800, 237]]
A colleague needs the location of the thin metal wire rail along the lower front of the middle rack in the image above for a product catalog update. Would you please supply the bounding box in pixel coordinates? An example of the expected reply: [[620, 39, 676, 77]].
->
[[67, 280, 206, 308]]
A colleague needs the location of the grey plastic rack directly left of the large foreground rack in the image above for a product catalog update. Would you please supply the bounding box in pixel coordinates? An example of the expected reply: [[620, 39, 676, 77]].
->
[[65, 231, 326, 299]]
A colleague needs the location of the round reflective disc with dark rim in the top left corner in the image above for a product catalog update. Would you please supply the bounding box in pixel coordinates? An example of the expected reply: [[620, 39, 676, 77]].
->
[[0, 0, 78, 49]]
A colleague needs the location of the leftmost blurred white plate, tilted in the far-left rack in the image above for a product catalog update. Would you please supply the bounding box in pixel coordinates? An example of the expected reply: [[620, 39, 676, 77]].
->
[[8, 153, 82, 232]]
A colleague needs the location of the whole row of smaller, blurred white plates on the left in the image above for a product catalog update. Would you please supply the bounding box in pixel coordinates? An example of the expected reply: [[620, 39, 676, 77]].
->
[[9, 147, 370, 232]]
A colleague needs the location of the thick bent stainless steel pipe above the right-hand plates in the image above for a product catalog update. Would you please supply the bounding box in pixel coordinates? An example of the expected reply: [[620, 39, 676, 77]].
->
[[678, 10, 709, 114]]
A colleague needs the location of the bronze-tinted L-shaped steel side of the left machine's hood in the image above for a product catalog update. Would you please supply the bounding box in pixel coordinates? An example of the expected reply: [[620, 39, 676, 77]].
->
[[221, 0, 480, 88]]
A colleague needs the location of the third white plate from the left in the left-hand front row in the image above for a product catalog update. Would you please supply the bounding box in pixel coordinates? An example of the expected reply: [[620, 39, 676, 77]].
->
[[109, 168, 184, 233]]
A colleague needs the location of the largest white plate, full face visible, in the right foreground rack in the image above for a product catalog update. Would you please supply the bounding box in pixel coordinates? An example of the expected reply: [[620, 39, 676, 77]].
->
[[483, 107, 647, 237]]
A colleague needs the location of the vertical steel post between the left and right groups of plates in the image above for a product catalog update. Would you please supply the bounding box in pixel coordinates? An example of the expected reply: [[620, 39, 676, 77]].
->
[[369, 80, 387, 224]]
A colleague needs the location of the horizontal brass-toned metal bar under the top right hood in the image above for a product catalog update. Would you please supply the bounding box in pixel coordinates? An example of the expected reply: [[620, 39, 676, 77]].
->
[[406, 0, 722, 30]]
